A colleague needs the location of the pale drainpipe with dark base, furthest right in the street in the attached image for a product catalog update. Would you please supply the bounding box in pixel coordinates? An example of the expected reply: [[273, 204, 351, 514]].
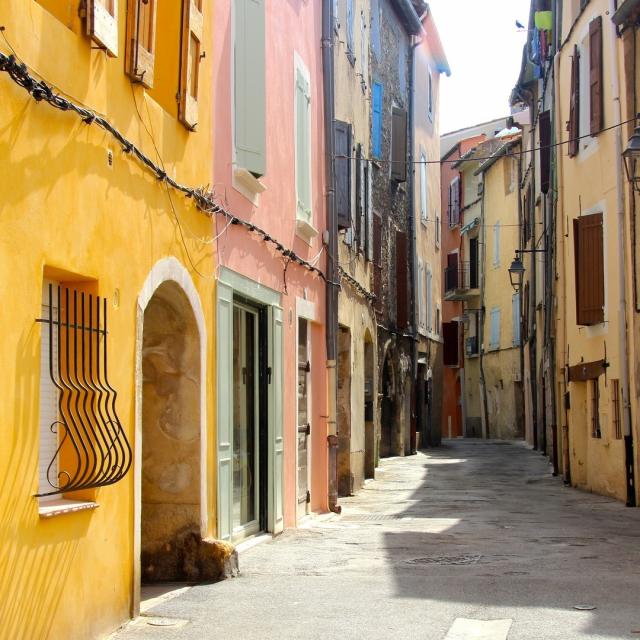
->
[[609, 0, 636, 507]]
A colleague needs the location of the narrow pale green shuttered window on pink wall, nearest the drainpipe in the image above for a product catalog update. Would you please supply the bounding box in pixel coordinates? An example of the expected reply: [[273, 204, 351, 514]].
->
[[295, 61, 314, 225]]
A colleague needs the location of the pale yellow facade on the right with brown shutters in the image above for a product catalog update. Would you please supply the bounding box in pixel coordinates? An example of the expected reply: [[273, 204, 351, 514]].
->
[[555, 1, 635, 500]]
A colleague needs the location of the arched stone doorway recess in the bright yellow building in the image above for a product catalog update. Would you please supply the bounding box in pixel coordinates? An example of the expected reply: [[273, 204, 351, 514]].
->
[[138, 280, 202, 583]]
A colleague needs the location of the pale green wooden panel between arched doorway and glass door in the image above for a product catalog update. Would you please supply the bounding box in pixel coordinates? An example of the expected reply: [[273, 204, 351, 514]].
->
[[216, 281, 233, 540]]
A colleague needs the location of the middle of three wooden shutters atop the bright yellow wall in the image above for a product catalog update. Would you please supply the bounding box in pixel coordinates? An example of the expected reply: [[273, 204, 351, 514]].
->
[[126, 0, 157, 89]]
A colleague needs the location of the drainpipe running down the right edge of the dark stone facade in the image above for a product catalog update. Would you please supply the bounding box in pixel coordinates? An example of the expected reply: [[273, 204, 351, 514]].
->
[[407, 37, 422, 454]]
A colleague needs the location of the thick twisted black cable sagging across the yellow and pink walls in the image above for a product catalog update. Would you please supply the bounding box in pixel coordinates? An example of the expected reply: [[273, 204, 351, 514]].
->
[[0, 53, 330, 286]]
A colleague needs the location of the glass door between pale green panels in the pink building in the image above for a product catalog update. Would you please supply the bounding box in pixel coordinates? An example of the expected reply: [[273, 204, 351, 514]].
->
[[233, 304, 260, 540]]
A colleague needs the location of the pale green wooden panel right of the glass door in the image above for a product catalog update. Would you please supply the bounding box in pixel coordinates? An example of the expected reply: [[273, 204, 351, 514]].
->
[[269, 307, 284, 533]]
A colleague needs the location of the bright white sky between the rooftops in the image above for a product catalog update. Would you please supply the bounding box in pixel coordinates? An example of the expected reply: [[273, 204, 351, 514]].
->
[[429, 0, 530, 133]]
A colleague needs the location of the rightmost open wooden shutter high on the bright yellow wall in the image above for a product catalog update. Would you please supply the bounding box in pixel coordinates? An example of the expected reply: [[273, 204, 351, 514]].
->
[[178, 0, 204, 130]]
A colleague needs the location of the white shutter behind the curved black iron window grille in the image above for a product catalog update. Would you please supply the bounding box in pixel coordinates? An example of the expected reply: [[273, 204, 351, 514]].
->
[[38, 280, 59, 500]]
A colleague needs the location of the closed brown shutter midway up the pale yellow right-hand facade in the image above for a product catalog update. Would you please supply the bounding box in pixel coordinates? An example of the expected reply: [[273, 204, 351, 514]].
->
[[573, 213, 604, 325]]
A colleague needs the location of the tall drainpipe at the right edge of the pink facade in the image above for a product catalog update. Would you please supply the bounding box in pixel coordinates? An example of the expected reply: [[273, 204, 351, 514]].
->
[[322, 0, 341, 513]]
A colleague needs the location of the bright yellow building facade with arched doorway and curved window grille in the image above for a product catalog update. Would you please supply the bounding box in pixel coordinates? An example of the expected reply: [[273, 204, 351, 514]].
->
[[0, 0, 216, 639]]
